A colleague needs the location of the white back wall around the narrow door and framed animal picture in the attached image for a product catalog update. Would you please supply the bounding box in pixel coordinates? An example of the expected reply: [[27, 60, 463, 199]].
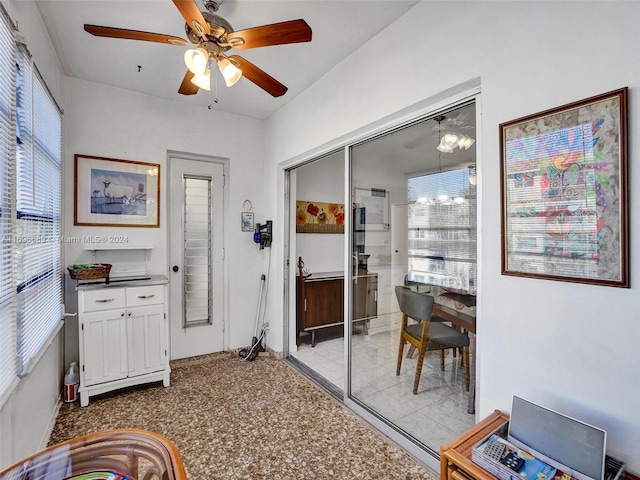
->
[[64, 78, 264, 361]]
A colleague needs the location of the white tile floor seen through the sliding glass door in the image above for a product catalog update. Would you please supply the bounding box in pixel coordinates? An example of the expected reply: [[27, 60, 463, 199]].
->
[[292, 314, 474, 452]]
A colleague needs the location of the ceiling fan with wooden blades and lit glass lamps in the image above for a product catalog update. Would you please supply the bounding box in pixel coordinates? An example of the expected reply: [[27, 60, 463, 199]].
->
[[84, 0, 311, 97]]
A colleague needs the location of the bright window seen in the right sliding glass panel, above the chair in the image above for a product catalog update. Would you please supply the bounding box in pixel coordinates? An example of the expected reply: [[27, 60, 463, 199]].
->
[[407, 168, 477, 294]]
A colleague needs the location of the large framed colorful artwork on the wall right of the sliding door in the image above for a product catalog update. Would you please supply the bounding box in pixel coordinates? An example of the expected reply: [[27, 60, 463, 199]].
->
[[500, 87, 629, 287]]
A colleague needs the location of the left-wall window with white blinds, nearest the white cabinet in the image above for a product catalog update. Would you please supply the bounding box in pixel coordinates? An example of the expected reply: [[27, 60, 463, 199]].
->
[[14, 47, 62, 375]]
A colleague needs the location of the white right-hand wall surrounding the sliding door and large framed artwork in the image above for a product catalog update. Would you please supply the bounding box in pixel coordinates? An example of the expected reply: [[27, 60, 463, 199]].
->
[[265, 1, 640, 474]]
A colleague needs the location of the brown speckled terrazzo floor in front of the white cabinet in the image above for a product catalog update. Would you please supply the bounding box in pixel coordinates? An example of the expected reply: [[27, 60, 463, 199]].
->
[[49, 353, 438, 480]]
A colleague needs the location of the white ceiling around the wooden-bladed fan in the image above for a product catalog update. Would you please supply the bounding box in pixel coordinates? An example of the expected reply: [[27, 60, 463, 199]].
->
[[36, 0, 418, 119]]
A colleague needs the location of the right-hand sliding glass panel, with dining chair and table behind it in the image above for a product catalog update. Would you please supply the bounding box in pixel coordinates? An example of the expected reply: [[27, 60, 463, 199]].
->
[[345, 103, 477, 454]]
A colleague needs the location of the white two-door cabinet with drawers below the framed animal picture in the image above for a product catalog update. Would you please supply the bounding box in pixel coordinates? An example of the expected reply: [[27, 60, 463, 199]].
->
[[77, 282, 170, 407]]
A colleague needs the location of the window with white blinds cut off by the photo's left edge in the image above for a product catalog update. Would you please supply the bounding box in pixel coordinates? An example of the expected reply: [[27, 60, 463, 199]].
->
[[0, 5, 17, 405]]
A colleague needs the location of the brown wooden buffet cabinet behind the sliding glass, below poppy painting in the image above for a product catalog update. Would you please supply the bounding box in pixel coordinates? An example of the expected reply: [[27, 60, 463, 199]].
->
[[296, 272, 378, 347]]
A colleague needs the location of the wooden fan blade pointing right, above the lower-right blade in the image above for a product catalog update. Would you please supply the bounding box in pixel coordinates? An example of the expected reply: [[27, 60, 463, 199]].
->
[[227, 20, 311, 50]]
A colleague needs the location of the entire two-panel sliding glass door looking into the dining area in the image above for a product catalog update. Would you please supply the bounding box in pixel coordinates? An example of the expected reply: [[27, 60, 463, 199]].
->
[[285, 101, 478, 458]]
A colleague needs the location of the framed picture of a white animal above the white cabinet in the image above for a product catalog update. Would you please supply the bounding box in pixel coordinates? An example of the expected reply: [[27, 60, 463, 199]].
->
[[73, 155, 160, 227]]
